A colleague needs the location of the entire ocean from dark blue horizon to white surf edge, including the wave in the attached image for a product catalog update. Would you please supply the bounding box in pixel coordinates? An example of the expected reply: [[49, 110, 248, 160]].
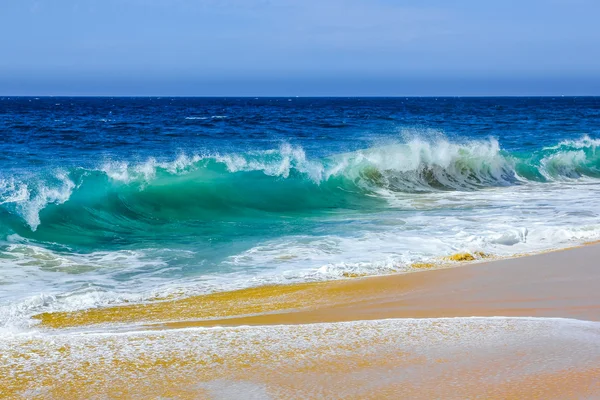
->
[[0, 97, 600, 325]]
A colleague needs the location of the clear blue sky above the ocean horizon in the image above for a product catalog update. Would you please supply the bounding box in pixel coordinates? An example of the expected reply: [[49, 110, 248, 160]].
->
[[0, 0, 600, 96]]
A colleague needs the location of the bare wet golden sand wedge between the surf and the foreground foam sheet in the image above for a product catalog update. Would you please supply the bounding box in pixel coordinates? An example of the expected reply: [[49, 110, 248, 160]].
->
[[34, 242, 600, 329]]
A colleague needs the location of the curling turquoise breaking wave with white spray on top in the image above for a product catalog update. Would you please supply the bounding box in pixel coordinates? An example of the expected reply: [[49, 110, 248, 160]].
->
[[0, 136, 600, 231]]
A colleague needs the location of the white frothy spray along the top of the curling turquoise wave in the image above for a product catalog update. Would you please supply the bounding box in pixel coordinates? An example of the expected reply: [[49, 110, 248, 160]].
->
[[89, 137, 595, 191]]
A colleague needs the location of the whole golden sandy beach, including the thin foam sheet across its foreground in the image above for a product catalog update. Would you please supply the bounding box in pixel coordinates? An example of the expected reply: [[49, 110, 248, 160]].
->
[[0, 244, 600, 399]]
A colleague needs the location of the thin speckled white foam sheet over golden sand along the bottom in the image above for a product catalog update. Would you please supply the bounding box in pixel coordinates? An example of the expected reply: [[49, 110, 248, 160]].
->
[[0, 317, 600, 398]]
